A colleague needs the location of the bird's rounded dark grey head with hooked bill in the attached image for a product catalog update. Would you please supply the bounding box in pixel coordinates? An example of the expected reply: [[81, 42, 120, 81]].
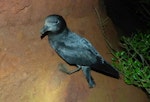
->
[[40, 14, 66, 39]]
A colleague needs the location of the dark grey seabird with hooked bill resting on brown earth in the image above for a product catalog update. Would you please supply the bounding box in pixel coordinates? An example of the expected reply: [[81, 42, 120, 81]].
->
[[40, 14, 119, 87]]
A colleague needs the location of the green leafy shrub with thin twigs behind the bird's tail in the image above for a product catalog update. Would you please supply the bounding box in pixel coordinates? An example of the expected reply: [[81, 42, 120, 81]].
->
[[112, 33, 150, 94]]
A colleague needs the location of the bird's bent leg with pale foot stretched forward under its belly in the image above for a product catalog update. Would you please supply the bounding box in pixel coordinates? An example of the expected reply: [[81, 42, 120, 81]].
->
[[59, 63, 81, 74]]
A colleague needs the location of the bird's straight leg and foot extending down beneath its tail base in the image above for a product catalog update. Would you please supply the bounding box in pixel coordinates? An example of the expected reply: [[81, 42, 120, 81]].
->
[[82, 66, 95, 88]]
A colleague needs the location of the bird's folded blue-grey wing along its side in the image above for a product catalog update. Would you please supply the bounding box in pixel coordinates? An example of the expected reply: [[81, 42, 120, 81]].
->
[[55, 34, 103, 66]]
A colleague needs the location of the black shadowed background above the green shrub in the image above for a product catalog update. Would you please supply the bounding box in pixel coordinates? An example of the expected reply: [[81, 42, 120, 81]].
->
[[104, 0, 150, 36]]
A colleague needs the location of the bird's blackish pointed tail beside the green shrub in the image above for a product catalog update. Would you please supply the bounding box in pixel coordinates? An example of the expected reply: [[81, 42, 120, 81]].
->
[[91, 61, 119, 79]]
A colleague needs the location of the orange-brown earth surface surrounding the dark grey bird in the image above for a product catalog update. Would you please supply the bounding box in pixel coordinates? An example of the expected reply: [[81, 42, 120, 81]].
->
[[0, 0, 149, 102]]
